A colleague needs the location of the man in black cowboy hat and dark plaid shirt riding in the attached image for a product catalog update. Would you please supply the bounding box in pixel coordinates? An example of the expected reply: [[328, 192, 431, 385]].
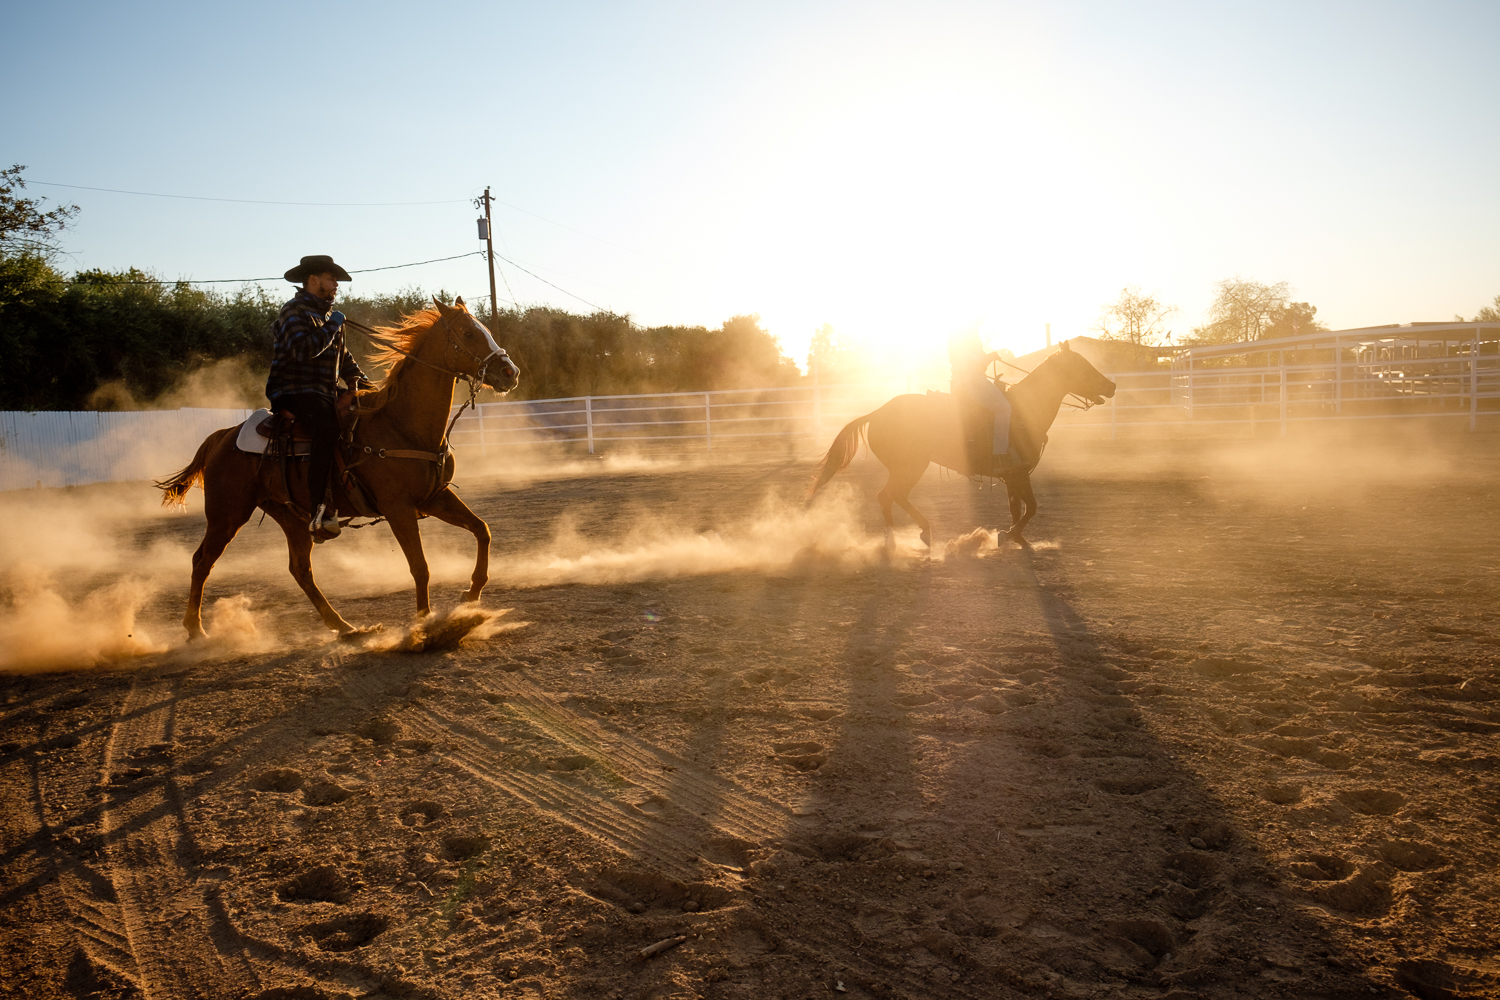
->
[[266, 255, 372, 541]]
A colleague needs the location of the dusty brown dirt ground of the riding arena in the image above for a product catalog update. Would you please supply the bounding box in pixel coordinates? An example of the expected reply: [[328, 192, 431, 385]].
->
[[0, 435, 1500, 1000]]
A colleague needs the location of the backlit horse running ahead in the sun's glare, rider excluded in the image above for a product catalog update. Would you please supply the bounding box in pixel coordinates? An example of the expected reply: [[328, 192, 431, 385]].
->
[[810, 342, 1115, 546]]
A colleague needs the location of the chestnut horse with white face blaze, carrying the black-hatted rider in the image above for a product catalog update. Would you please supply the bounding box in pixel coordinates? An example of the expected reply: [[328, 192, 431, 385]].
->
[[156, 298, 521, 639]]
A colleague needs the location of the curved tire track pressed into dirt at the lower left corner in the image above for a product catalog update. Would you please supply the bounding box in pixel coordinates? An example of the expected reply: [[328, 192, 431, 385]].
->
[[91, 681, 260, 1000]]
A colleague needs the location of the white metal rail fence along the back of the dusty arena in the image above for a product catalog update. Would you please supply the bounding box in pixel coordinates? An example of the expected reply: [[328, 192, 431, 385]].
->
[[0, 324, 1500, 490]]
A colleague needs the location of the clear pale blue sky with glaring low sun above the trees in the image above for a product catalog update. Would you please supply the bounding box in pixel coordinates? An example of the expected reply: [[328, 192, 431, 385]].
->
[[0, 0, 1500, 367]]
